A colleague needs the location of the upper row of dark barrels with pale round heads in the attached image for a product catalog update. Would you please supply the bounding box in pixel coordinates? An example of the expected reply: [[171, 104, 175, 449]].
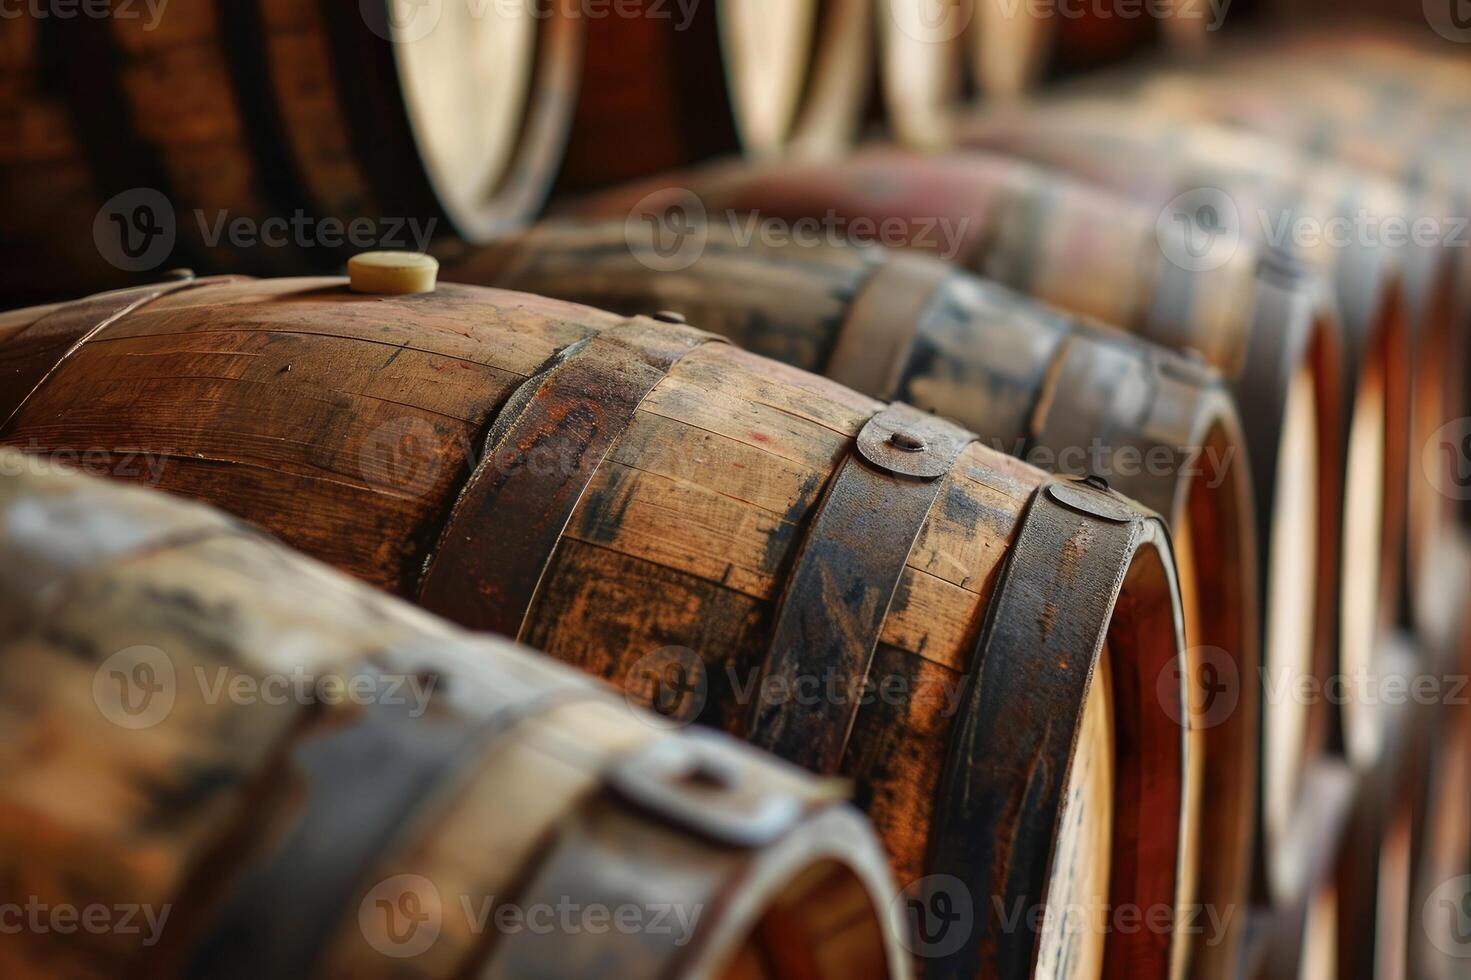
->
[[0, 0, 1202, 300]]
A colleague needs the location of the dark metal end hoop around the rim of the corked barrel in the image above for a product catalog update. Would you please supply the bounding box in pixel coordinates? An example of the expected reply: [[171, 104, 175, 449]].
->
[[924, 480, 1150, 979]]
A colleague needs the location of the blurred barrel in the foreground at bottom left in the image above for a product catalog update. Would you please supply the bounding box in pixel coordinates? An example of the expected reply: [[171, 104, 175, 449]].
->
[[0, 450, 909, 980]]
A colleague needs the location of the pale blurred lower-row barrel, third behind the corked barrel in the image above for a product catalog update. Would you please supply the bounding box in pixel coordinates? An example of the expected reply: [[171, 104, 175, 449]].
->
[[965, 100, 1418, 765]]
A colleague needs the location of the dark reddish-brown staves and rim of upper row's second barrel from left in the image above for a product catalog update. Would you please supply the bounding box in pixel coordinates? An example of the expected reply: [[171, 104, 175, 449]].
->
[[558, 0, 872, 193]]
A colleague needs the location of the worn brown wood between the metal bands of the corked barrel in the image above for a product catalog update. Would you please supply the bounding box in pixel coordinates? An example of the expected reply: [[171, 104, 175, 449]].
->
[[0, 280, 1193, 968]]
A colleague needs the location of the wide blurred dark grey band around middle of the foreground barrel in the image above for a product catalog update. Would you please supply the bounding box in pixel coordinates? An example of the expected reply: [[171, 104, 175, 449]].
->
[[182, 672, 600, 980]]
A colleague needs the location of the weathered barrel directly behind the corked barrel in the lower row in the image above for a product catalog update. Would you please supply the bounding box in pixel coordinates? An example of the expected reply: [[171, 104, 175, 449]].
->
[[446, 222, 1265, 976]]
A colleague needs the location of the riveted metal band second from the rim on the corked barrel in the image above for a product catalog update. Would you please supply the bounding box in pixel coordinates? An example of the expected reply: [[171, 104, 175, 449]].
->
[[746, 403, 975, 773]]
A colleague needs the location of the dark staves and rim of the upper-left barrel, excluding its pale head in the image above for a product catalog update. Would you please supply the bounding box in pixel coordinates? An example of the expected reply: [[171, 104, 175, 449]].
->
[[0, 0, 584, 302]]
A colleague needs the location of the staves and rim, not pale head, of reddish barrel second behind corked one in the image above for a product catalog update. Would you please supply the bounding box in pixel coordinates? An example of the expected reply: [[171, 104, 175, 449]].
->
[[568, 147, 1346, 898]]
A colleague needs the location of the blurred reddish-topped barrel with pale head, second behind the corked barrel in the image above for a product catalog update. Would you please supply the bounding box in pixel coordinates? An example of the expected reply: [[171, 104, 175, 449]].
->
[[567, 149, 1343, 895]]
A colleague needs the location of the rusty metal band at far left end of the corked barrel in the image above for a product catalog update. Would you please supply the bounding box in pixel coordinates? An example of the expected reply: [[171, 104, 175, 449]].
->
[[0, 274, 215, 434]]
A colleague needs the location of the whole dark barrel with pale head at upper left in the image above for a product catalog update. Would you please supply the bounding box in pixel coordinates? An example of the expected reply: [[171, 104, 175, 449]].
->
[[0, 0, 584, 296]]
